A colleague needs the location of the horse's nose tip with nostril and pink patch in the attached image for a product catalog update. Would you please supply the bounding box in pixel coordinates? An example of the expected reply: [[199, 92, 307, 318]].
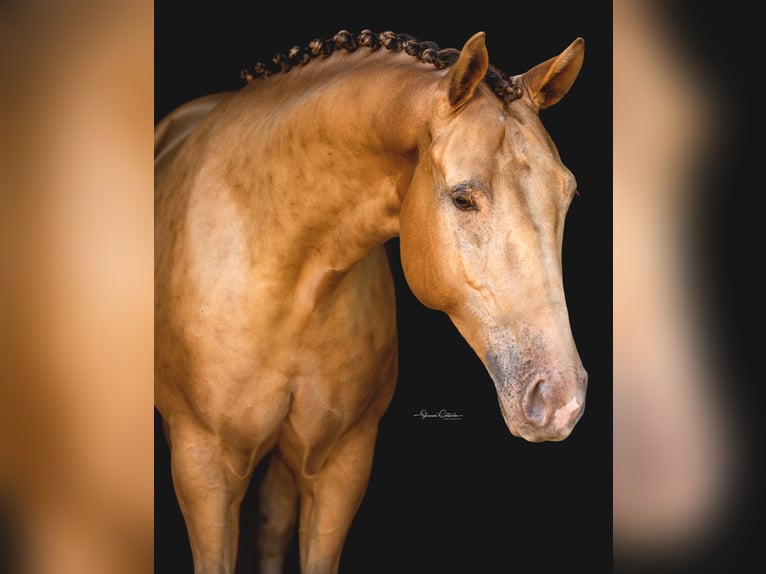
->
[[521, 372, 588, 440]]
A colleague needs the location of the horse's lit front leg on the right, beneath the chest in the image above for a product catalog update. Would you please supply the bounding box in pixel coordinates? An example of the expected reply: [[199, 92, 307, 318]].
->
[[299, 421, 377, 574]]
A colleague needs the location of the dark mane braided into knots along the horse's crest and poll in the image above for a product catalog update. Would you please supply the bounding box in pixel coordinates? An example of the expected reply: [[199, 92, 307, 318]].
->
[[240, 29, 521, 103]]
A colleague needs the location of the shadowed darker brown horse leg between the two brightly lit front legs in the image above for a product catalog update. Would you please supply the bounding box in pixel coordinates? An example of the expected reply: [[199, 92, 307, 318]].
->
[[257, 455, 298, 574]]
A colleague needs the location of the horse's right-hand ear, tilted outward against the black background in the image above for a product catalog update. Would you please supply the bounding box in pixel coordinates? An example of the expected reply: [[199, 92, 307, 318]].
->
[[514, 38, 585, 110]]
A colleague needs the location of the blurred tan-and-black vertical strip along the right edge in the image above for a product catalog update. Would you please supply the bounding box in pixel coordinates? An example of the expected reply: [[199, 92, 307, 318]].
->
[[614, 0, 766, 574]]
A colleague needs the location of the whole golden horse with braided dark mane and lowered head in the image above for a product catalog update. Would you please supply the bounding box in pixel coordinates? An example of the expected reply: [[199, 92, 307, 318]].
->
[[155, 30, 587, 574]]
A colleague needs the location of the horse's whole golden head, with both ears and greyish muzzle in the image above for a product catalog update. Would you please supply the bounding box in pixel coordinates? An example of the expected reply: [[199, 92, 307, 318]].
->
[[399, 32, 587, 442]]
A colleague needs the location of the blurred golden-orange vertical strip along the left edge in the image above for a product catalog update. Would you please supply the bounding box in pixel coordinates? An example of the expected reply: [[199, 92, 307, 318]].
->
[[0, 0, 154, 574]]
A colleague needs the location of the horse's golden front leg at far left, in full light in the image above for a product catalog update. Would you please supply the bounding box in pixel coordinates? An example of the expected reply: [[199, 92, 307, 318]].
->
[[170, 418, 253, 574]]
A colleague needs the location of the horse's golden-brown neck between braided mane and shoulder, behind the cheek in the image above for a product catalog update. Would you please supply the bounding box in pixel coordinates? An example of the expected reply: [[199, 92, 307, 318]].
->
[[210, 53, 440, 306]]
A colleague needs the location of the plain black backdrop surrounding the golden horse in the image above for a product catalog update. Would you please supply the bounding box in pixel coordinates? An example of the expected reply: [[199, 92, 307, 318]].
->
[[155, 1, 612, 574]]
